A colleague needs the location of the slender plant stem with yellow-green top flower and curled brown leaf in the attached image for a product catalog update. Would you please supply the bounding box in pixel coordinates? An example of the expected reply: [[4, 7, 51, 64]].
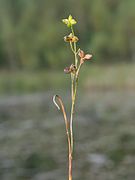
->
[[53, 15, 92, 180]]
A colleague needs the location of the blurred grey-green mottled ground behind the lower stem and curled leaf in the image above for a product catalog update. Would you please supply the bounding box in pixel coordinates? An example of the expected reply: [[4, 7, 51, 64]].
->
[[0, 92, 135, 180]]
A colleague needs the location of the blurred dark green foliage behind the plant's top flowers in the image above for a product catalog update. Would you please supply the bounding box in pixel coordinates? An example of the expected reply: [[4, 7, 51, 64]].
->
[[0, 0, 135, 69]]
